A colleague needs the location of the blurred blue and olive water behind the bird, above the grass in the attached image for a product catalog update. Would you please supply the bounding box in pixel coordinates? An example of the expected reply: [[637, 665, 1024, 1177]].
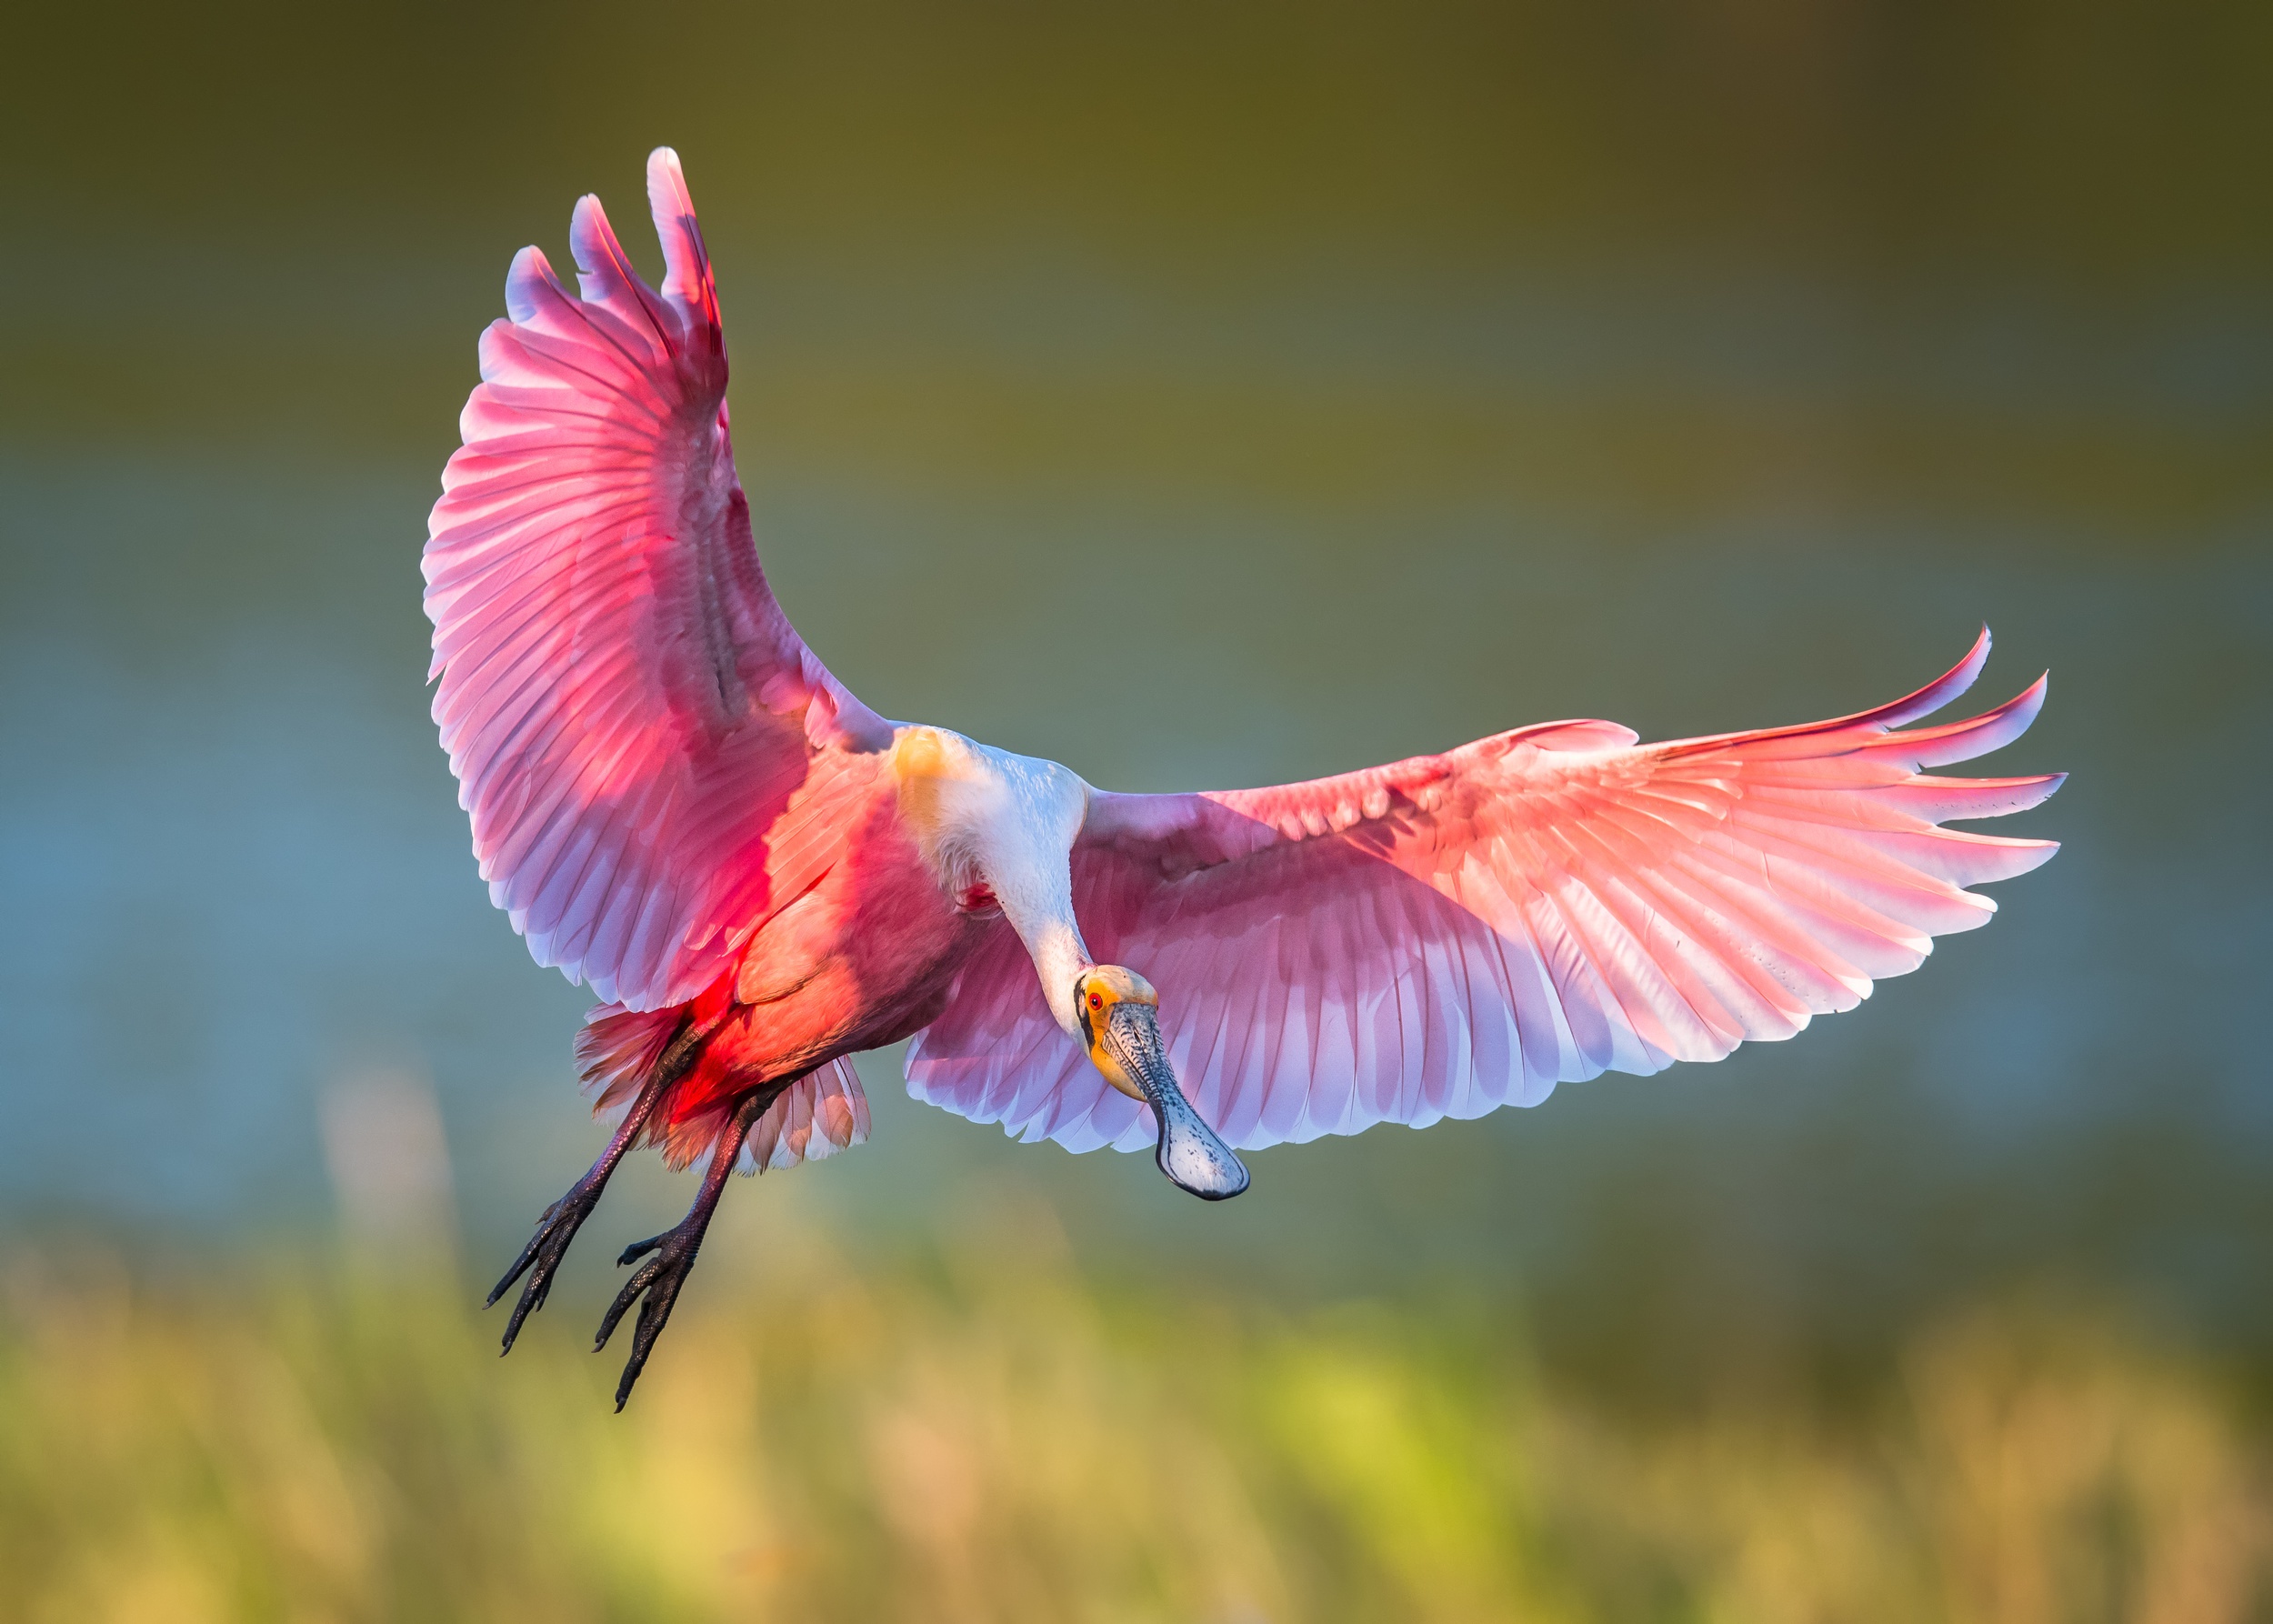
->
[[0, 9, 2273, 1376]]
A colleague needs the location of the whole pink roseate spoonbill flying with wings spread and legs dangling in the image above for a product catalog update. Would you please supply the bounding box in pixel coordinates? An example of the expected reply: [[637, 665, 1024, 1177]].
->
[[426, 148, 2059, 1408]]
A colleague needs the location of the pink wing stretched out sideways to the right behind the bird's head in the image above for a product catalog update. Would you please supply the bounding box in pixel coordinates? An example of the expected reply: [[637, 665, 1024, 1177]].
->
[[907, 630, 2062, 1148]]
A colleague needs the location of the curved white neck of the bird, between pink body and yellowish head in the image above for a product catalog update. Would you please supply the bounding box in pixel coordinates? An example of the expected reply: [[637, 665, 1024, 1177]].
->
[[891, 727, 1096, 1038]]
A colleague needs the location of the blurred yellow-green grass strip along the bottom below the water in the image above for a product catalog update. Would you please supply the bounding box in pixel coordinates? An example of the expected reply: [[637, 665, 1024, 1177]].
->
[[0, 1210, 2273, 1624]]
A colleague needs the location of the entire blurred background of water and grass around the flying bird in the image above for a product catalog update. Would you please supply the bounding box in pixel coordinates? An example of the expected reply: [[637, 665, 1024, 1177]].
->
[[0, 0, 2273, 1624]]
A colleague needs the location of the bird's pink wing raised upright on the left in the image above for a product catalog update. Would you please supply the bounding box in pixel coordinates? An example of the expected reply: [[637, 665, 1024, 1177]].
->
[[426, 148, 891, 1010]]
